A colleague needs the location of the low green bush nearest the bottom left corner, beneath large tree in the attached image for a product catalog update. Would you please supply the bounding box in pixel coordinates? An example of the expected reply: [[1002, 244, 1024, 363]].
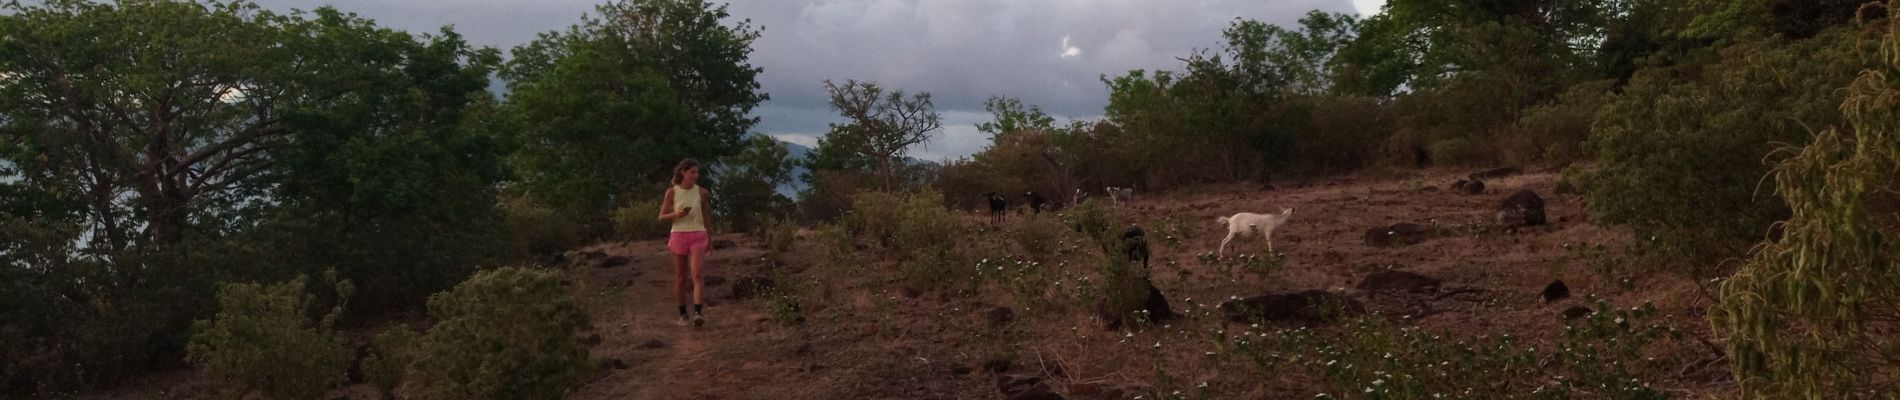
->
[[186, 277, 352, 398]]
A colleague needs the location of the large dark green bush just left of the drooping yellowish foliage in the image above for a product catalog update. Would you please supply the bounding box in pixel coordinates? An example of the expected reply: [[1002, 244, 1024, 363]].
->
[[1579, 30, 1858, 260]]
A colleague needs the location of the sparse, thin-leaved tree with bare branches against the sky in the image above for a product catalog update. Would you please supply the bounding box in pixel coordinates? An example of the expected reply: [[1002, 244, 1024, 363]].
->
[[813, 80, 942, 190]]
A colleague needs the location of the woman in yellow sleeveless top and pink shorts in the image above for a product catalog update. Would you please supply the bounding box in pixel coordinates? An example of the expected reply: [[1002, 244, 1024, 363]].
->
[[659, 159, 713, 326]]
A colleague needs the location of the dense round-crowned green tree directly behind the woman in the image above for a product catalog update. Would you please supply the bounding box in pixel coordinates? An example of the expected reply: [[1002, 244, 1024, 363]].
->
[[504, 0, 766, 228]]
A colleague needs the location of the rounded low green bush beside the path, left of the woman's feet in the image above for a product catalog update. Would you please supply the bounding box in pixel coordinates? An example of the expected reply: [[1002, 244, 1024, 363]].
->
[[409, 267, 593, 398]]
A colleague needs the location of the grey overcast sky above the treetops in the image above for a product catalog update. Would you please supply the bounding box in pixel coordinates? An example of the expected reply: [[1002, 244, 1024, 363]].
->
[[255, 0, 1385, 161]]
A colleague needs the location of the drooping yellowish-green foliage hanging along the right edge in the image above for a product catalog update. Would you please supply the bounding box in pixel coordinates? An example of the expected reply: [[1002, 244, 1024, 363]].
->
[[1710, 2, 1900, 398]]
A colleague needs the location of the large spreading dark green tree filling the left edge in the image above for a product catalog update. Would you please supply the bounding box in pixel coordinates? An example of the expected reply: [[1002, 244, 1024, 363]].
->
[[0, 0, 502, 392]]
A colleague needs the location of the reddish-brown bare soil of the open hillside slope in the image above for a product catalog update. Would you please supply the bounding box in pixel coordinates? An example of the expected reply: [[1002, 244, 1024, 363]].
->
[[81, 171, 1733, 400]]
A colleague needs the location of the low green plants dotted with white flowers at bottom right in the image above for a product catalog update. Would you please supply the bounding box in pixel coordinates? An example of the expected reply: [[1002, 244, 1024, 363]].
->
[[1210, 298, 1680, 400]]
